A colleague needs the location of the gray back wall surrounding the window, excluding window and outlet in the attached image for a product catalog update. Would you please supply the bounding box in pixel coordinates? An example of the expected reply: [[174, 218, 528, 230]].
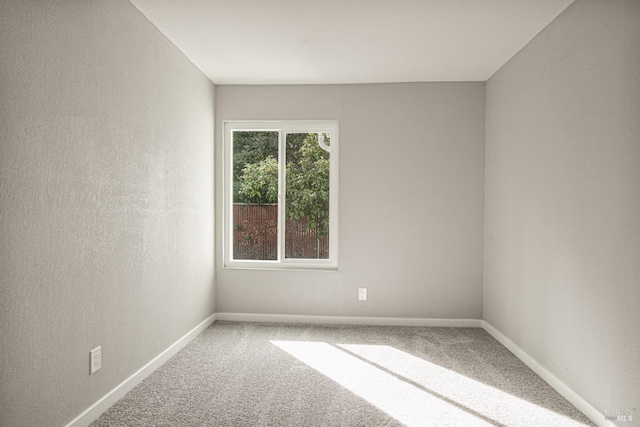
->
[[216, 83, 485, 319]]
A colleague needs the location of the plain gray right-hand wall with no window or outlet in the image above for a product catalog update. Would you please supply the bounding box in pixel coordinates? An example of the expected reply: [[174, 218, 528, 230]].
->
[[484, 0, 640, 418]]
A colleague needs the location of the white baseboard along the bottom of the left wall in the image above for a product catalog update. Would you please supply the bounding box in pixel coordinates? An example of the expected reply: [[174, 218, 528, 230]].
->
[[66, 314, 216, 427]]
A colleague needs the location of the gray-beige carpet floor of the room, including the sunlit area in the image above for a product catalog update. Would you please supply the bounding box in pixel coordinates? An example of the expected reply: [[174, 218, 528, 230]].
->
[[91, 322, 594, 427]]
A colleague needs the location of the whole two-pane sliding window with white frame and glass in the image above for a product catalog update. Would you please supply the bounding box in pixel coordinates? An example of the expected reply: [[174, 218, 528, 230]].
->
[[223, 121, 338, 269]]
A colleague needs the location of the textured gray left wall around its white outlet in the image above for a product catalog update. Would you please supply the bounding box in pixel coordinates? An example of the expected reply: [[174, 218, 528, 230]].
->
[[0, 0, 214, 426]]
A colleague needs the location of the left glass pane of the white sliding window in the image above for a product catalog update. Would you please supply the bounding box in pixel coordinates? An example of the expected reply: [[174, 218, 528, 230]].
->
[[231, 131, 278, 260]]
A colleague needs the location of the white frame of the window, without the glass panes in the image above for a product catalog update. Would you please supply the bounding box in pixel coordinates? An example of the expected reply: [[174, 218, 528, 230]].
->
[[222, 120, 339, 270]]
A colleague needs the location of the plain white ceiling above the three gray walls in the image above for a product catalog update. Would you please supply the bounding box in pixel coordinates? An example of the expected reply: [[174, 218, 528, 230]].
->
[[131, 0, 573, 84]]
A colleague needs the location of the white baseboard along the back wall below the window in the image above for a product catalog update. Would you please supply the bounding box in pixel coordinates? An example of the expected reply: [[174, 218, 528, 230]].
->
[[216, 313, 482, 328]]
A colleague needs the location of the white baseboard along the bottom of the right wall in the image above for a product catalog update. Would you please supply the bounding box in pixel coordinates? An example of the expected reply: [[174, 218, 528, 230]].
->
[[482, 320, 617, 427]]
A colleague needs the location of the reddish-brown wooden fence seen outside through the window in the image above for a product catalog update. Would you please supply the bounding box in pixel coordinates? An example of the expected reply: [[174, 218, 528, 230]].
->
[[233, 203, 329, 260]]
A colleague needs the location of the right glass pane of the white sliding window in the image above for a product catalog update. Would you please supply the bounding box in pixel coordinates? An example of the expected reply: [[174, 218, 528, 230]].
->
[[285, 133, 331, 259]]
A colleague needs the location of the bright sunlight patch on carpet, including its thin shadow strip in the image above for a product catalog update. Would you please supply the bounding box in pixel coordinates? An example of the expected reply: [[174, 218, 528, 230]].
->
[[271, 341, 585, 427]]
